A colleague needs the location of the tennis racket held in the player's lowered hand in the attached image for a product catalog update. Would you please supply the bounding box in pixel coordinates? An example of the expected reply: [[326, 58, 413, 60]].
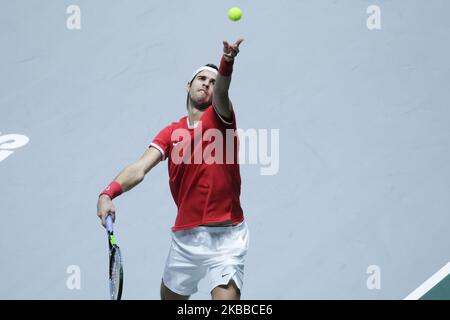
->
[[106, 215, 123, 300]]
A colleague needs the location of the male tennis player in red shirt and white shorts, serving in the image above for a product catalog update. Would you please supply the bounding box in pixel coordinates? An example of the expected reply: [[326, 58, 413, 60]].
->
[[97, 39, 249, 300]]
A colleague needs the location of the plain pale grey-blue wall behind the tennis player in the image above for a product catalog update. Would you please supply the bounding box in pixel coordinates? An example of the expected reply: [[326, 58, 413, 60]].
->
[[0, 0, 450, 299]]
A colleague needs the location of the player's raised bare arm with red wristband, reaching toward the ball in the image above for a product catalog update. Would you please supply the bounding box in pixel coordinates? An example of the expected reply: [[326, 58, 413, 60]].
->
[[212, 39, 244, 120]]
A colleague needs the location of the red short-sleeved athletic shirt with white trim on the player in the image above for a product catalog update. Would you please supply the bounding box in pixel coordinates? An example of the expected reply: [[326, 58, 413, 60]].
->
[[149, 105, 244, 231]]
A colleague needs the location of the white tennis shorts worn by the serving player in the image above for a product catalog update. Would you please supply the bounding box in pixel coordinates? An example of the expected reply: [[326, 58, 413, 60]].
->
[[162, 221, 249, 296]]
